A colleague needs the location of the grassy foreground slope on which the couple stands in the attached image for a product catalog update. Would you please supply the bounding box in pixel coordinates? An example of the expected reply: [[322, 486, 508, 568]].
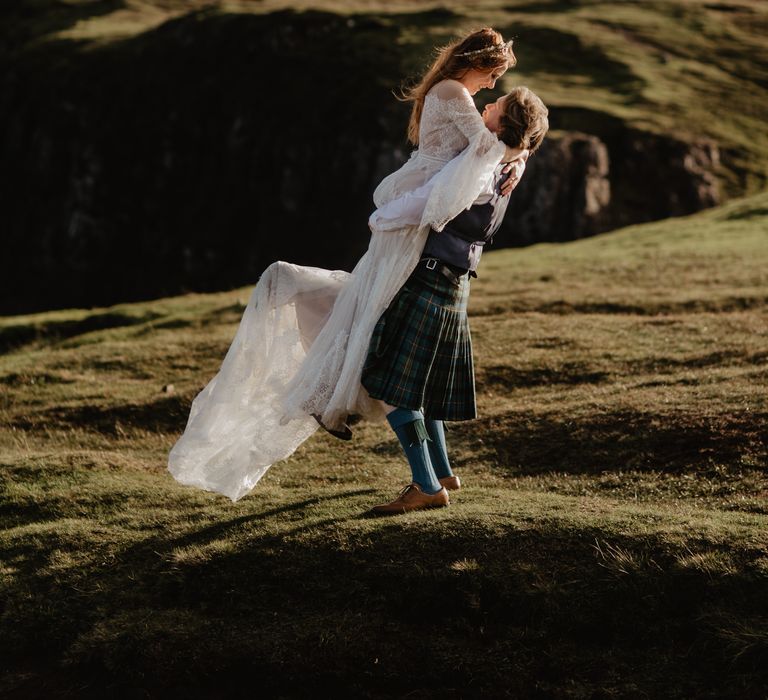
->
[[0, 194, 768, 698]]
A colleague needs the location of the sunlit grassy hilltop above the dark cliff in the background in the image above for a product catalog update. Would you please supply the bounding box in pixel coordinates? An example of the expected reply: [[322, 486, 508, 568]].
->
[[6, 0, 768, 196]]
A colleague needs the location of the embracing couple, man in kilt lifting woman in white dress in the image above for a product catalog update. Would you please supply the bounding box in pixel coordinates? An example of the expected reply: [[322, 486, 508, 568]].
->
[[169, 28, 548, 515]]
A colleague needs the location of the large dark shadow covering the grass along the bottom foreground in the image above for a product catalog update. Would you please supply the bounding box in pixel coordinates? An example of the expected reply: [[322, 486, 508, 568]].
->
[[0, 500, 768, 698]]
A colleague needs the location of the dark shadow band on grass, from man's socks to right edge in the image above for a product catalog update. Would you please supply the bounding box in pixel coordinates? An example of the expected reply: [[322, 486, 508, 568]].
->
[[468, 411, 768, 474]]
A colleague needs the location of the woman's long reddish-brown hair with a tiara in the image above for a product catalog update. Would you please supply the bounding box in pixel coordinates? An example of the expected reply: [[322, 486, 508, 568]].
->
[[398, 27, 517, 146]]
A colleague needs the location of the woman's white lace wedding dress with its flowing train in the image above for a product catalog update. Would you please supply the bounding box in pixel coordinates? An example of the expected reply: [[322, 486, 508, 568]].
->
[[168, 81, 505, 501]]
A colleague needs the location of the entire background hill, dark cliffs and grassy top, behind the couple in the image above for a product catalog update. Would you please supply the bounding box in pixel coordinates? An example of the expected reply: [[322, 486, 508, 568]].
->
[[0, 0, 768, 313]]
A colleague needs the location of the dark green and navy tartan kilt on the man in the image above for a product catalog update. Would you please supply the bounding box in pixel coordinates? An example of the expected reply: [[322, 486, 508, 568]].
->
[[362, 263, 477, 420]]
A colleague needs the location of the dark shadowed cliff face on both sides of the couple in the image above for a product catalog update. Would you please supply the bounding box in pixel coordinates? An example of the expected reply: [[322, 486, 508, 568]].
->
[[0, 8, 717, 313]]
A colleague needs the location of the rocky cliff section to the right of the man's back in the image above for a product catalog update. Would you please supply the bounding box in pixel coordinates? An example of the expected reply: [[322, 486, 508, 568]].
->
[[499, 129, 720, 245]]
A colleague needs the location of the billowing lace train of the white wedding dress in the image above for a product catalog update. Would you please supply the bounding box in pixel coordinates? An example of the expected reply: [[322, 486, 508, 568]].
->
[[168, 262, 349, 501]]
